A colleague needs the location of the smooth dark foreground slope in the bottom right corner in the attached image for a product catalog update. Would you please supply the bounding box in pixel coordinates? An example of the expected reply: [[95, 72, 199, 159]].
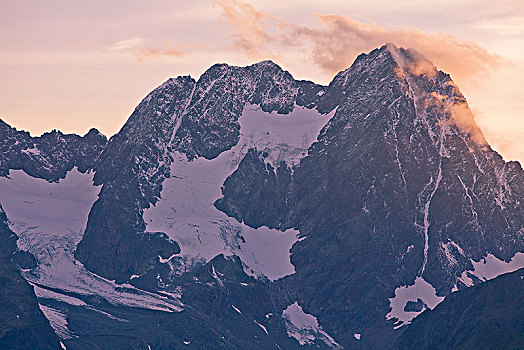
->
[[394, 269, 524, 349]]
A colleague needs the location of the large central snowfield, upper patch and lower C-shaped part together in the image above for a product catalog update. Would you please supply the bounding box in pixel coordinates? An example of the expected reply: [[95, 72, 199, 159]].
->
[[143, 105, 334, 280]]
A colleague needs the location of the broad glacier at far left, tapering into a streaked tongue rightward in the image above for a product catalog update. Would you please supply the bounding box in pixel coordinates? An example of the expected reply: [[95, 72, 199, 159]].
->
[[0, 168, 182, 312]]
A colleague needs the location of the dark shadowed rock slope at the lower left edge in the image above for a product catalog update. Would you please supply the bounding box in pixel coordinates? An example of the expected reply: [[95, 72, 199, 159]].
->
[[0, 206, 60, 349]]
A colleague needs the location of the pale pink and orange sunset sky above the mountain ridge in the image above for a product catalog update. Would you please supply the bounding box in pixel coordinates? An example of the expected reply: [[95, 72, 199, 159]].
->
[[0, 0, 524, 164]]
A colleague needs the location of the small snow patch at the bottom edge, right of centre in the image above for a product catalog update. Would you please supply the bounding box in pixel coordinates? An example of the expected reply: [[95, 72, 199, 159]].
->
[[282, 302, 342, 349]]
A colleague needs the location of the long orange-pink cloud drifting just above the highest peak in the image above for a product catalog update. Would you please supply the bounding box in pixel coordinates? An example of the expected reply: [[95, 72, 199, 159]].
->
[[218, 0, 507, 84]]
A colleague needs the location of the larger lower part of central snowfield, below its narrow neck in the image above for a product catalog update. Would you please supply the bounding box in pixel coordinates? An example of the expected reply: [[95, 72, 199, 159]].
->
[[144, 149, 298, 280]]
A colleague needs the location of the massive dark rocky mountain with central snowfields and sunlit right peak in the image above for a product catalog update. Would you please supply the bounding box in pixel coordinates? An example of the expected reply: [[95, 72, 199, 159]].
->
[[0, 44, 524, 349]]
